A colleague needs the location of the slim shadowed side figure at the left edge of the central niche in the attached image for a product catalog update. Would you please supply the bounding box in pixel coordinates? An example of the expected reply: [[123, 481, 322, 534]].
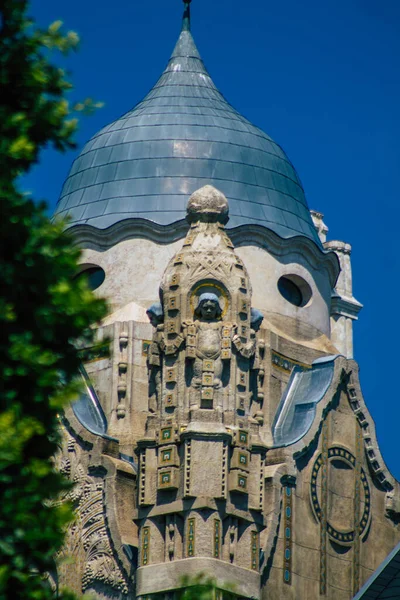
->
[[146, 302, 164, 413]]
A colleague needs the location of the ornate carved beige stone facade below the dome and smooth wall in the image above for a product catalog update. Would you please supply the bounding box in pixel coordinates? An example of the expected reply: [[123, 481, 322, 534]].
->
[[58, 186, 400, 600]]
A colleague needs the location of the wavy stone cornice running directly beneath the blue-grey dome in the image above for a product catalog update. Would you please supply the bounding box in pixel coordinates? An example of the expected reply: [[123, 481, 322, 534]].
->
[[68, 219, 340, 287]]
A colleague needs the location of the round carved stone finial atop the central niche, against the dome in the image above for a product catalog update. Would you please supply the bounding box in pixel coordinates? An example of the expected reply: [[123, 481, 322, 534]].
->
[[186, 185, 229, 223]]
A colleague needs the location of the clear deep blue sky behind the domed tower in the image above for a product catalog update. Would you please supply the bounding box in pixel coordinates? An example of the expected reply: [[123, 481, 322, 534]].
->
[[24, 0, 400, 479]]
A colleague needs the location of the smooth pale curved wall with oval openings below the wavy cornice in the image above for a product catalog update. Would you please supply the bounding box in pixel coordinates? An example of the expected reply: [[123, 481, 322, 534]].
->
[[75, 227, 337, 335]]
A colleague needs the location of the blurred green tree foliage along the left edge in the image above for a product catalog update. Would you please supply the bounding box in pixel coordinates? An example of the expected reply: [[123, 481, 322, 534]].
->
[[0, 0, 105, 600]]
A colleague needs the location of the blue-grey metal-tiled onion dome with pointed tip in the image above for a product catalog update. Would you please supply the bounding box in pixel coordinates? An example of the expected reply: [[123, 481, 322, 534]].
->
[[56, 5, 321, 247]]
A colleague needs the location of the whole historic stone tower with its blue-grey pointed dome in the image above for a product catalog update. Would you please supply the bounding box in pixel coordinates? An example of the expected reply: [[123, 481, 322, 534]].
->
[[53, 0, 400, 600]]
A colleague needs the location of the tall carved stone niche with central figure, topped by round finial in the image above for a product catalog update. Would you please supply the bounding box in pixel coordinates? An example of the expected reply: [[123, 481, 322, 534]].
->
[[149, 186, 262, 414]]
